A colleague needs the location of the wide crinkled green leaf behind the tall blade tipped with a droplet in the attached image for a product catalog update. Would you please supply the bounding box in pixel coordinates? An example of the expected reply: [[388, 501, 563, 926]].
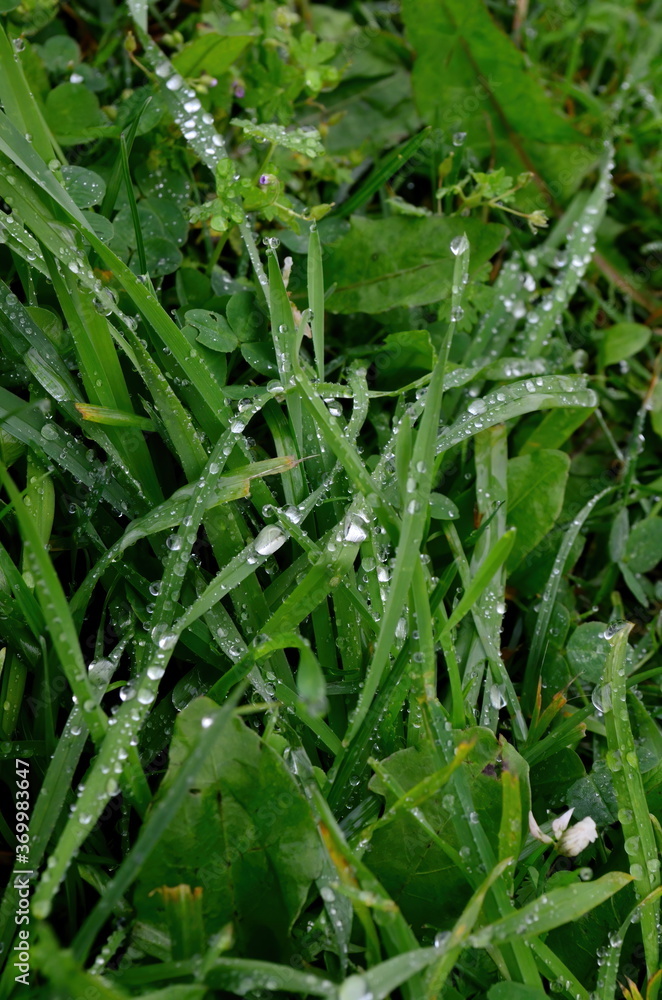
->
[[324, 216, 505, 313]]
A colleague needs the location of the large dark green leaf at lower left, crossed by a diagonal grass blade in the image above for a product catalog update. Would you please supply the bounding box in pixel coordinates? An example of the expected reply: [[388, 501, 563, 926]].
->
[[135, 698, 321, 955]]
